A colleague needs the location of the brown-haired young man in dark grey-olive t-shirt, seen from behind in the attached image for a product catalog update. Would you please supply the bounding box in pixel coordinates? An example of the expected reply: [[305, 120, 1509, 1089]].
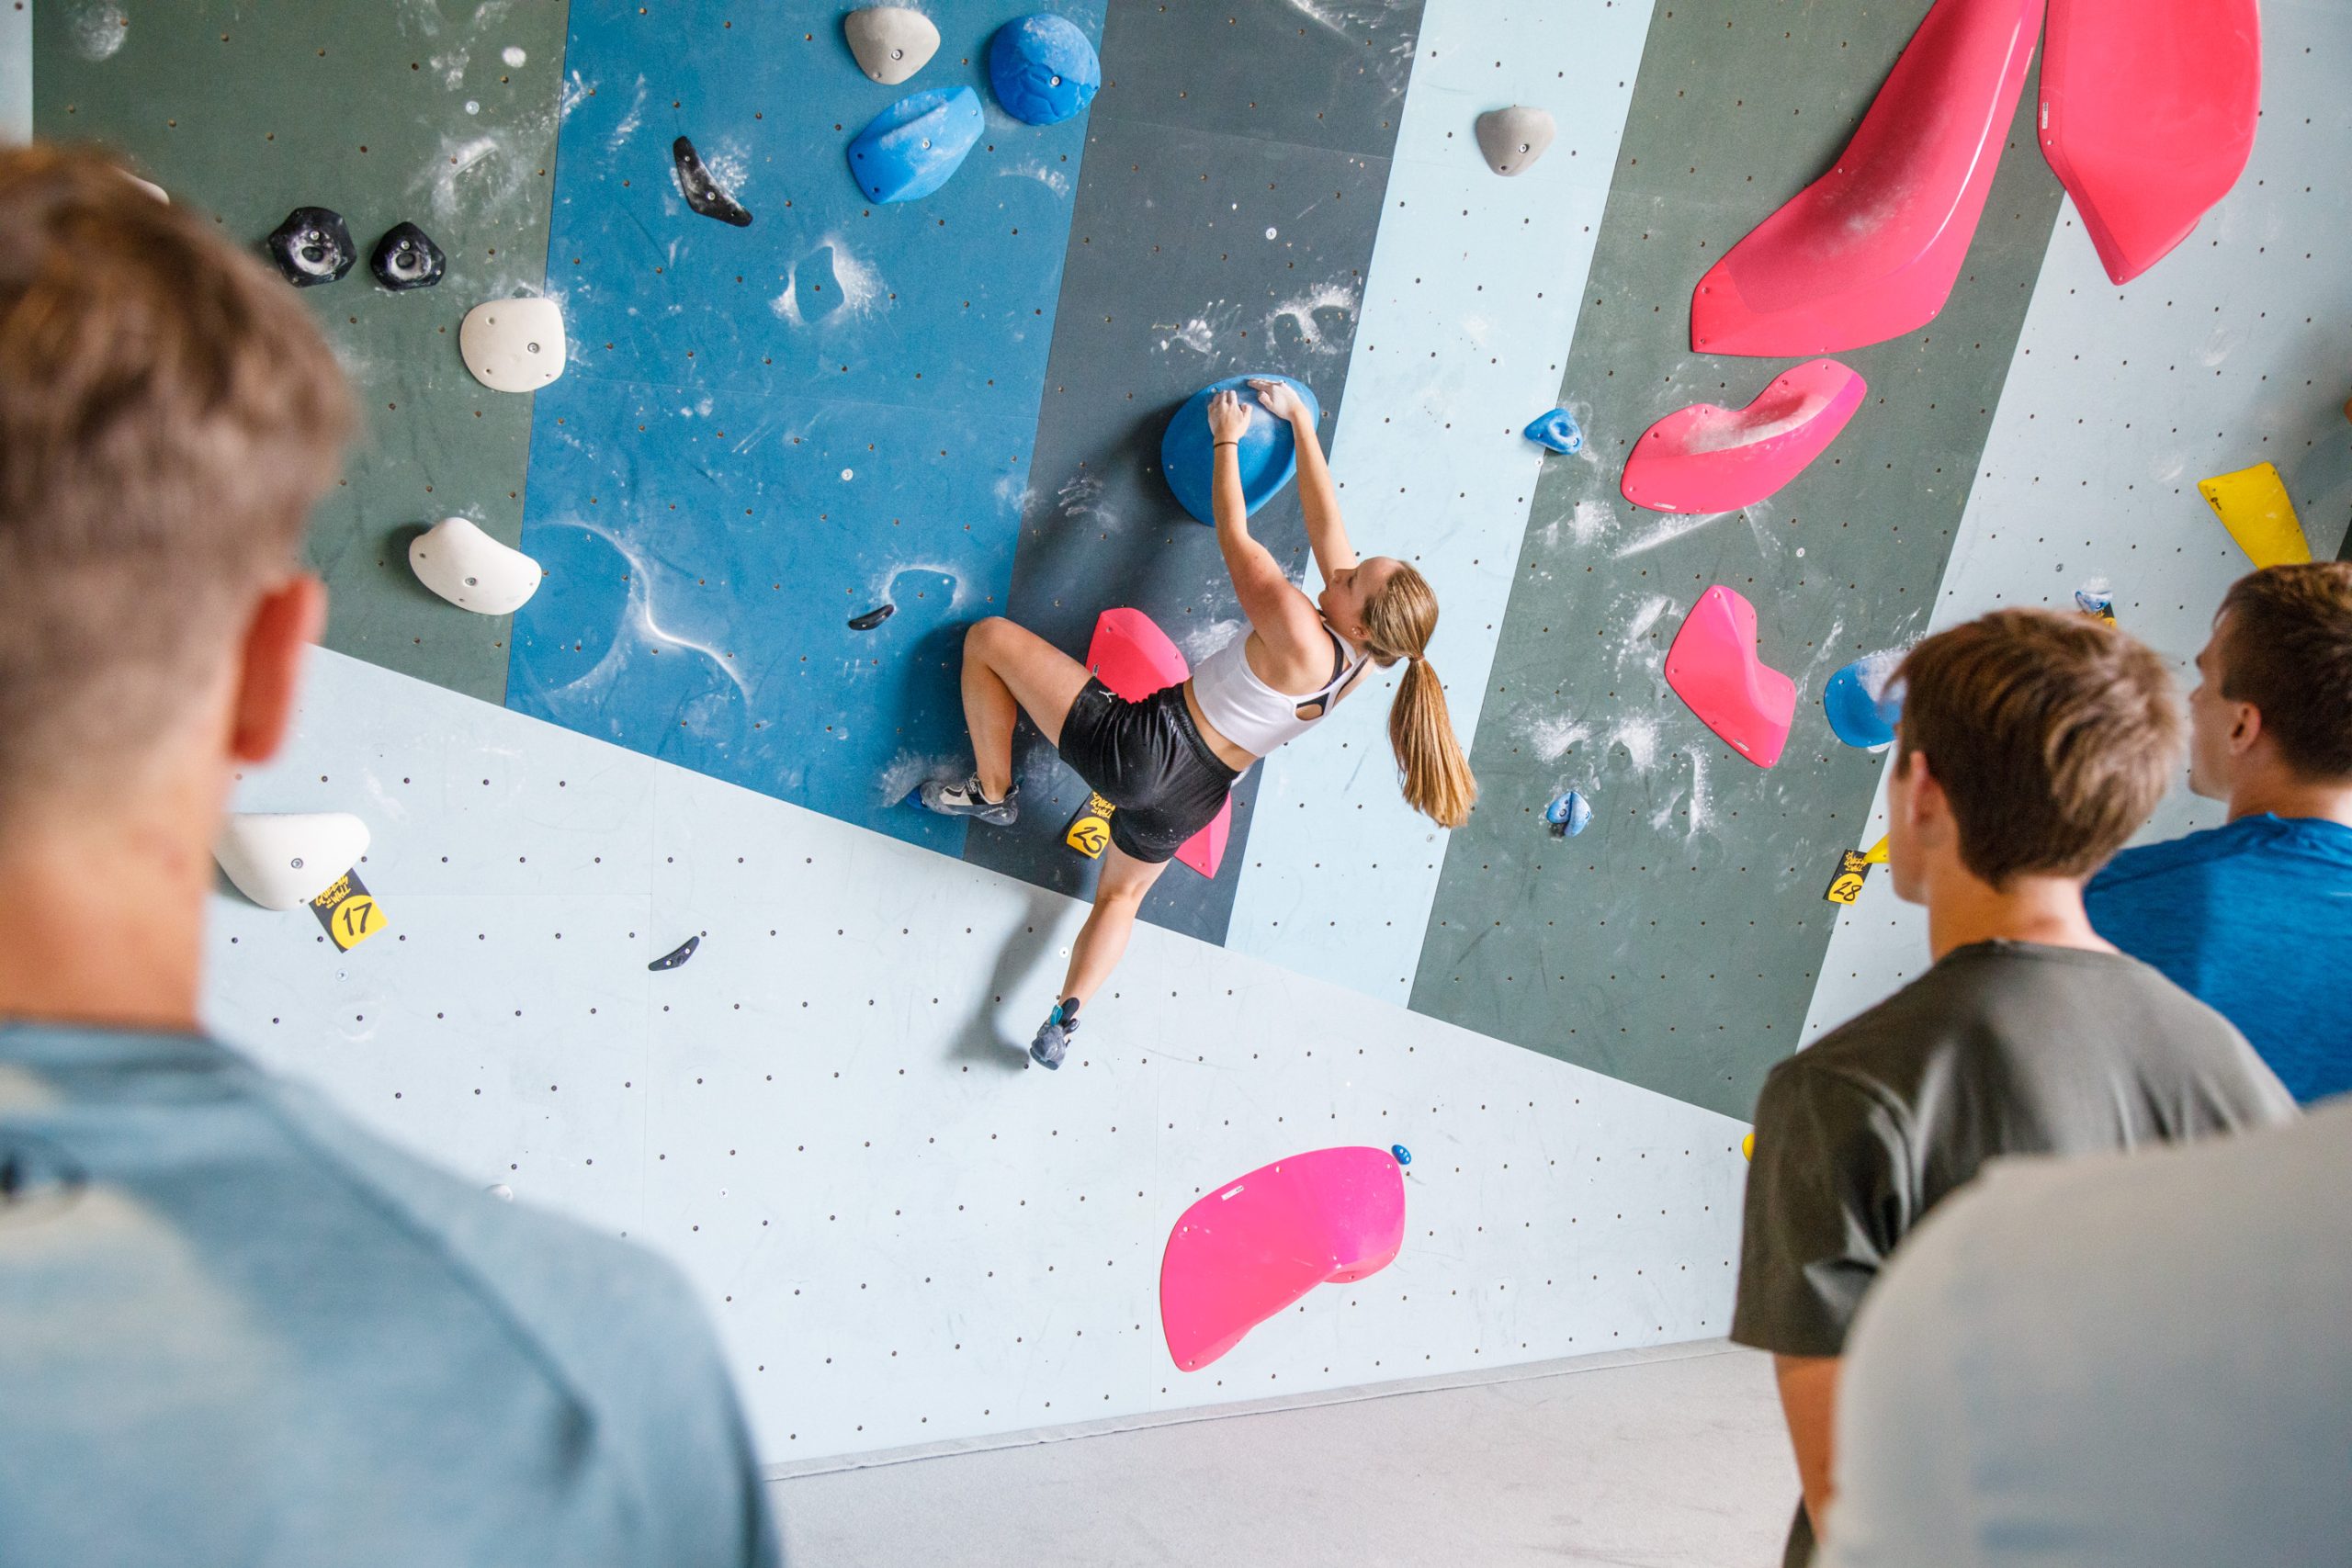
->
[[1731, 611, 2293, 1563]]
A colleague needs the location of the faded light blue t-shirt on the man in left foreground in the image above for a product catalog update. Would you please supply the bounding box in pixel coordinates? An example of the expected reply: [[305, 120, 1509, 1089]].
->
[[0, 1025, 778, 1568]]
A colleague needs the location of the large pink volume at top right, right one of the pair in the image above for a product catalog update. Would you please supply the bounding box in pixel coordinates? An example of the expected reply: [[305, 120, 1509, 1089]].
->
[[2041, 0, 2263, 282]]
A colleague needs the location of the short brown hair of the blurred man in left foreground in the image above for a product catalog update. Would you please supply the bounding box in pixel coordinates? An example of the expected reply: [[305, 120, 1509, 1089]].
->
[[0, 146, 350, 808]]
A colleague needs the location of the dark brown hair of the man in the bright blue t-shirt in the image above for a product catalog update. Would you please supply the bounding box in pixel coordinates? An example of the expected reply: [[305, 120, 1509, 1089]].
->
[[2213, 562, 2352, 778]]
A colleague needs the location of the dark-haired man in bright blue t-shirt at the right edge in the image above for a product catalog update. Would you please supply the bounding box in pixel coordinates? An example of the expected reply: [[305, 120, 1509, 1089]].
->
[[2084, 562, 2352, 1105]]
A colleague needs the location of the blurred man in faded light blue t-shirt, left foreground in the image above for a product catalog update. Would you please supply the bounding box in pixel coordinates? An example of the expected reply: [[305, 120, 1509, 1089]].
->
[[0, 148, 778, 1568]]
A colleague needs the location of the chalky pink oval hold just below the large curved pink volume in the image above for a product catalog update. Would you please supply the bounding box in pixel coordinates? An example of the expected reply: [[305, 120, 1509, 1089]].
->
[[1618, 360, 1870, 513]]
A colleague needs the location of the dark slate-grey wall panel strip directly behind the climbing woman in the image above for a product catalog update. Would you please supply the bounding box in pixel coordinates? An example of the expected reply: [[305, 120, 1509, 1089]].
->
[[965, 0, 1420, 941]]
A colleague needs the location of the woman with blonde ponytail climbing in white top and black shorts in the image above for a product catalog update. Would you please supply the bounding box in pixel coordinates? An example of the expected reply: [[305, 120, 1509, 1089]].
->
[[922, 381, 1477, 1067]]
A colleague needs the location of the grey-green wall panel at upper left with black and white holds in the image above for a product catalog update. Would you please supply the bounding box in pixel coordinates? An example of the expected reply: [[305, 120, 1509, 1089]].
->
[[33, 0, 564, 703]]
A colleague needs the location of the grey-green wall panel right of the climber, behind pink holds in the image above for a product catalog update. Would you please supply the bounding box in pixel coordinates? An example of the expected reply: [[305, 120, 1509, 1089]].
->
[[1414, 0, 2058, 1114]]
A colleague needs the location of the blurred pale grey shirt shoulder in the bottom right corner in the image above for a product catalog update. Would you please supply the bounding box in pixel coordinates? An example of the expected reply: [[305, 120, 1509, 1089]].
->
[[1818, 1102, 2352, 1568]]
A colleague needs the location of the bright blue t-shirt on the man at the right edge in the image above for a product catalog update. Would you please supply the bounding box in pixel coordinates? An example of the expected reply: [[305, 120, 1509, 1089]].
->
[[2084, 813, 2352, 1105]]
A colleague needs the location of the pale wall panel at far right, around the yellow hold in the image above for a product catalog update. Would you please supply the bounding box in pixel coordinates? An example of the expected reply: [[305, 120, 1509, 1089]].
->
[[1804, 0, 2352, 1042]]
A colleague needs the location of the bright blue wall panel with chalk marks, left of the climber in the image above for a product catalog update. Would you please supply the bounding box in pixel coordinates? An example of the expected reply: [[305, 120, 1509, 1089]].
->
[[508, 0, 1103, 853]]
